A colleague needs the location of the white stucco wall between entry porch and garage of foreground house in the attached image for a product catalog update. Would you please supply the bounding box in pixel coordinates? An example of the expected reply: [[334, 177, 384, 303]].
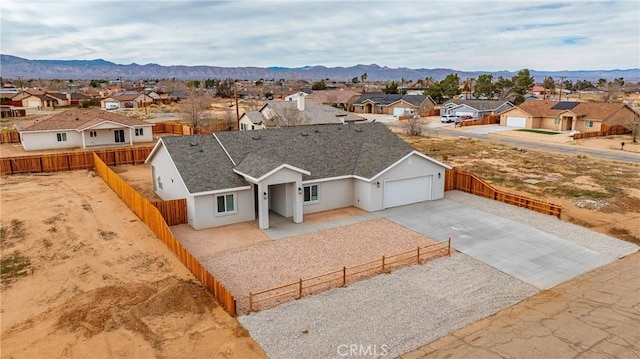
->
[[302, 178, 354, 213]]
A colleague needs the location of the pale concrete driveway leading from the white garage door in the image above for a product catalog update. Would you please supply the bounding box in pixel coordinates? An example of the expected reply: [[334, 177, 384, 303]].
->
[[384, 199, 616, 289]]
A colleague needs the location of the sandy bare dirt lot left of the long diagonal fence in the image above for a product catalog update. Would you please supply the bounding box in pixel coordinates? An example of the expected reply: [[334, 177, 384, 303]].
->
[[0, 171, 265, 358]]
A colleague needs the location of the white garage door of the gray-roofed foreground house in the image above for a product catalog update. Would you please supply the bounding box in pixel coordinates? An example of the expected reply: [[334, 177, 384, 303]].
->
[[384, 176, 433, 208]]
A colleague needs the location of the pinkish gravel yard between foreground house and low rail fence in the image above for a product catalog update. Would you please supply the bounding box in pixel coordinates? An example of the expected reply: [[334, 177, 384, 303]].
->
[[203, 219, 434, 313]]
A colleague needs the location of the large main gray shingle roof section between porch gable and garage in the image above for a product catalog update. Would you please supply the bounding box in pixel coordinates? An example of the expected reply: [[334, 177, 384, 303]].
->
[[215, 123, 413, 180]]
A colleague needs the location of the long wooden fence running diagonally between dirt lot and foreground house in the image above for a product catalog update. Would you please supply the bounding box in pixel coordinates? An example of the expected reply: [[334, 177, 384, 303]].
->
[[93, 154, 236, 316]]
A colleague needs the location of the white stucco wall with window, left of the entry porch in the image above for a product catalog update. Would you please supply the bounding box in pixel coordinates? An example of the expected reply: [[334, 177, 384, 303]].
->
[[187, 189, 256, 230]]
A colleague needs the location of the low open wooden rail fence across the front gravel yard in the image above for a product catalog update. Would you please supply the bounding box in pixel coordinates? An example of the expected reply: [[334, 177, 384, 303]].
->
[[249, 237, 451, 313]]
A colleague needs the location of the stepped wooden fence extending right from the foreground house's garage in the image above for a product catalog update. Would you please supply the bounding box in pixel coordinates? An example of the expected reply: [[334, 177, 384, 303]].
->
[[445, 168, 562, 218]]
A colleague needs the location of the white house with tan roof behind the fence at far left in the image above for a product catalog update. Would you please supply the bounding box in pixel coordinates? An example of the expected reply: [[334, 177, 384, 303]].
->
[[15, 109, 153, 151]]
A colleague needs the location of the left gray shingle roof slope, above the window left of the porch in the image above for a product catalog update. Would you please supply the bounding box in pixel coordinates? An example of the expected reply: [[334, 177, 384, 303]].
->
[[162, 135, 248, 193]]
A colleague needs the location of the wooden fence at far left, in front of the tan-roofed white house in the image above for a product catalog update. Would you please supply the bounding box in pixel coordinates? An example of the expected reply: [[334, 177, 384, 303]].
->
[[0, 146, 153, 174]]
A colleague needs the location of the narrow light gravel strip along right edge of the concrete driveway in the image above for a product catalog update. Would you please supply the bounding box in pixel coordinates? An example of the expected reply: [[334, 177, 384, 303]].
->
[[445, 191, 639, 258]]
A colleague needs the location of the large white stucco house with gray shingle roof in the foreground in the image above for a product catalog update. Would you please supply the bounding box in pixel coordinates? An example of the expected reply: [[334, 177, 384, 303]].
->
[[146, 123, 450, 229]]
